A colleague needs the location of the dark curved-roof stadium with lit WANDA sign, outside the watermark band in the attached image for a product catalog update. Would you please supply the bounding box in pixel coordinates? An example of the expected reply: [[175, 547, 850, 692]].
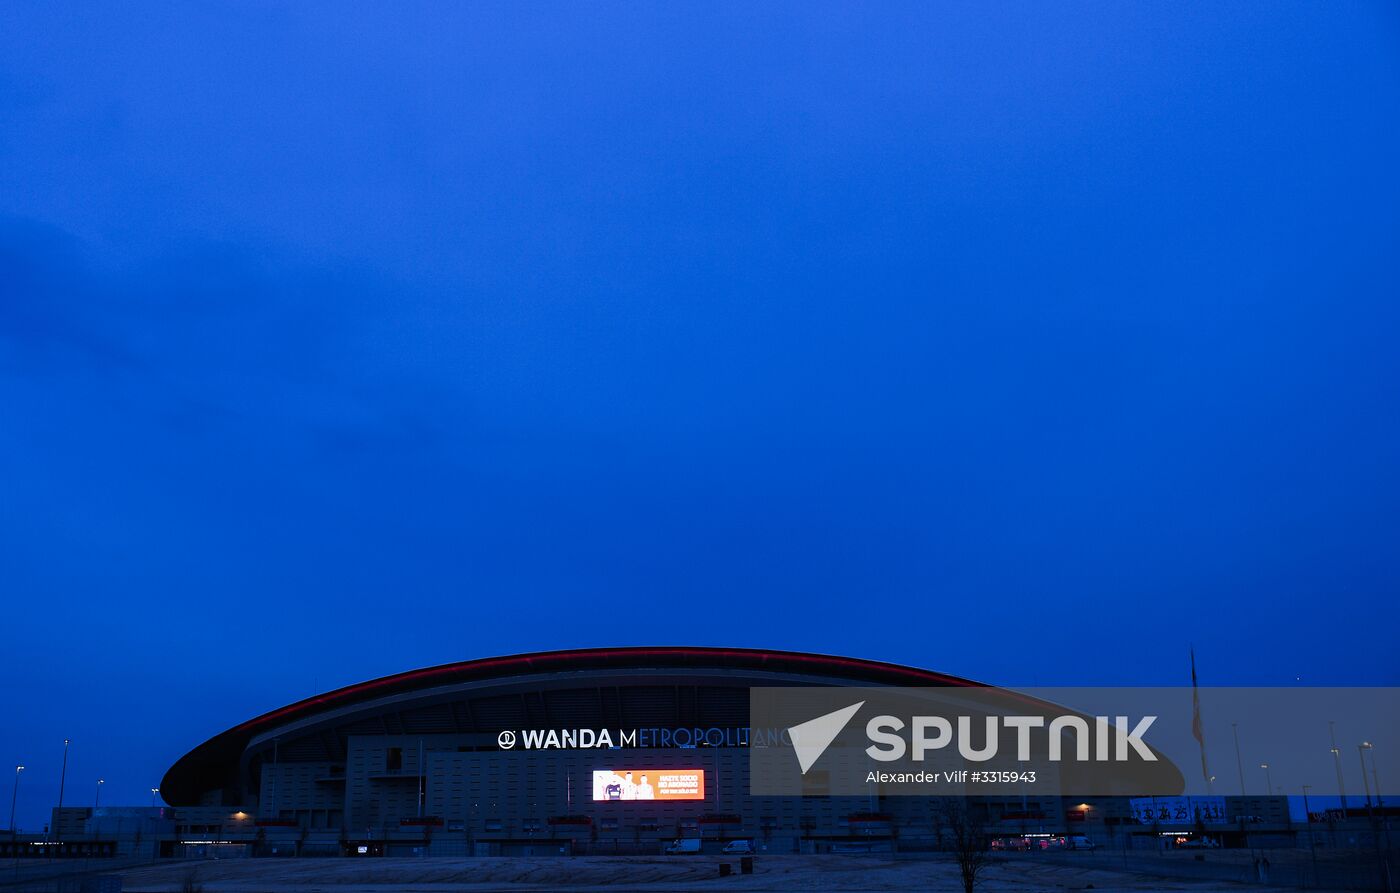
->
[[27, 647, 1288, 855]]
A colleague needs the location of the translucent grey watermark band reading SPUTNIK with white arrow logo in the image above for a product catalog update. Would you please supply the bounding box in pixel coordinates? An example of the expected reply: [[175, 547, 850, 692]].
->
[[749, 684, 1400, 799]]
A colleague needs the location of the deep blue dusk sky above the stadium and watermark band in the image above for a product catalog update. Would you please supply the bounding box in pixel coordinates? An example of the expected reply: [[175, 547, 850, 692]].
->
[[0, 1, 1400, 827]]
